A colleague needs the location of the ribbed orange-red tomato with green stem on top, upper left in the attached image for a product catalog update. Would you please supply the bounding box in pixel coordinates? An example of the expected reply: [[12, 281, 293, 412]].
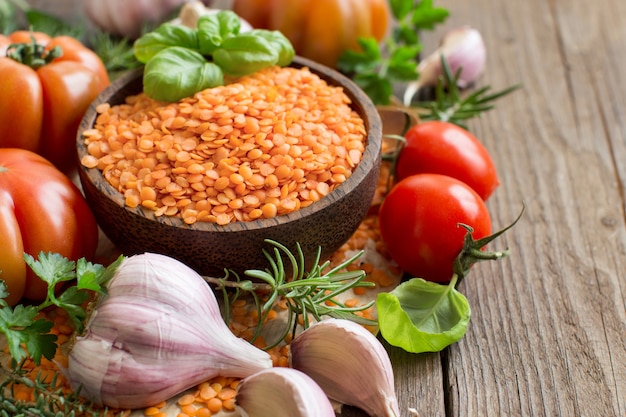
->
[[0, 31, 109, 171]]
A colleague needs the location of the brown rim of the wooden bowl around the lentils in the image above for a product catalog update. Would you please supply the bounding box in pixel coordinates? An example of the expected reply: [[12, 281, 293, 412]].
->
[[76, 56, 382, 233]]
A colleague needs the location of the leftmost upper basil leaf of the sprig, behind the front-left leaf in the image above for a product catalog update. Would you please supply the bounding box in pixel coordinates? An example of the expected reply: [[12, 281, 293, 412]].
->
[[133, 23, 199, 64]]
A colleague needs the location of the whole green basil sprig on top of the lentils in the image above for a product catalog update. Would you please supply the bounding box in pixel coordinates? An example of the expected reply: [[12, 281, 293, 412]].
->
[[133, 10, 295, 102]]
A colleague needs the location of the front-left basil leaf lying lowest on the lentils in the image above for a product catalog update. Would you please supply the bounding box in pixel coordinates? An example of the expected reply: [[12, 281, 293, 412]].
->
[[143, 46, 224, 102]]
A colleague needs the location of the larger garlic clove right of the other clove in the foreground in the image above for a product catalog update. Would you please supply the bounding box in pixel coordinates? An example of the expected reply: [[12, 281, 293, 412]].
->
[[291, 319, 400, 417]]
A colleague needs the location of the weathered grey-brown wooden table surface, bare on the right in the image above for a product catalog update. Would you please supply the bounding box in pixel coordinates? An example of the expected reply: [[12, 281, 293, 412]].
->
[[22, 0, 626, 417]]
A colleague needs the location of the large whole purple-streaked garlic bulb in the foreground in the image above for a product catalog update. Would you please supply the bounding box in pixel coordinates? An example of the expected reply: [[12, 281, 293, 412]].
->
[[67, 253, 272, 409]]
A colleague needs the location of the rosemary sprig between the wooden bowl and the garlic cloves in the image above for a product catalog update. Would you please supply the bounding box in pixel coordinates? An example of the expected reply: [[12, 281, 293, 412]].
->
[[204, 240, 376, 349]]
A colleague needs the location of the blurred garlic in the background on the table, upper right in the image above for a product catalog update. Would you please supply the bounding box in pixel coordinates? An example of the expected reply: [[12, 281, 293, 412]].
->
[[404, 26, 487, 106]]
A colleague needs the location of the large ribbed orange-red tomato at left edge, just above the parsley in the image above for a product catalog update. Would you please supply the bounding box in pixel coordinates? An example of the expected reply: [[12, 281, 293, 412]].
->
[[0, 148, 98, 305]]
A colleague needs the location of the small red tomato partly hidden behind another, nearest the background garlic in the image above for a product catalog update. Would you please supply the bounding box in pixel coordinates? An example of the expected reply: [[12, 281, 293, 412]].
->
[[396, 121, 500, 200]]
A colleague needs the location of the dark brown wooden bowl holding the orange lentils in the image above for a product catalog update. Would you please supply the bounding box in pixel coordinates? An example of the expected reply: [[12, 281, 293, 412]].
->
[[76, 57, 382, 276]]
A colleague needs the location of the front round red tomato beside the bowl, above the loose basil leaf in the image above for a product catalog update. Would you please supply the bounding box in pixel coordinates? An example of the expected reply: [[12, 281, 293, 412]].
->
[[379, 174, 491, 282]]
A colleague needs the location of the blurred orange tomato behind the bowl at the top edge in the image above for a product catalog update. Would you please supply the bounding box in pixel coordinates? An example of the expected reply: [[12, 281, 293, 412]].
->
[[234, 0, 391, 67]]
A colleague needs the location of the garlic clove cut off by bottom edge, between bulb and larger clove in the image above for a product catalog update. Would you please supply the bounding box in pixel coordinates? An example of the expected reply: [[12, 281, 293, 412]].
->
[[236, 368, 335, 417]]
